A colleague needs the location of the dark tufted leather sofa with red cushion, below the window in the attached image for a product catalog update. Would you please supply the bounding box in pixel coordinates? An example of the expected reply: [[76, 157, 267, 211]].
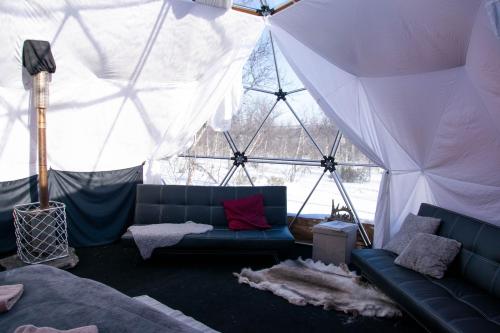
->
[[122, 185, 294, 254]]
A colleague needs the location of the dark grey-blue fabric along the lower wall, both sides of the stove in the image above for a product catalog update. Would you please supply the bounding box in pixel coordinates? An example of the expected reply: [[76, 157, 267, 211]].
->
[[0, 165, 142, 253]]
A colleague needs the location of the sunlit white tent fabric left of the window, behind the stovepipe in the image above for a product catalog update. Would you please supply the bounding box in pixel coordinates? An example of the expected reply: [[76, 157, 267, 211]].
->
[[0, 0, 264, 181]]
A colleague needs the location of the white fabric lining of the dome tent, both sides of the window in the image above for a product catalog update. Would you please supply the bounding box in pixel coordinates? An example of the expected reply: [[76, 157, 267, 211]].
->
[[0, 0, 500, 246]]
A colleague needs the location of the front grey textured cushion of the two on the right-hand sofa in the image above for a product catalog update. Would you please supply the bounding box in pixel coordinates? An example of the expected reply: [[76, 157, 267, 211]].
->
[[394, 233, 462, 279]]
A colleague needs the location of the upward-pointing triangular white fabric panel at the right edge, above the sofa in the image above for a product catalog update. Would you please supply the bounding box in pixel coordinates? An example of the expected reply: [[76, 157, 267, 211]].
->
[[424, 74, 500, 187]]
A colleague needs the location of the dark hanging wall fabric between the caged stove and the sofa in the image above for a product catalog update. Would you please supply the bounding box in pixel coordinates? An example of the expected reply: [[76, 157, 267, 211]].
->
[[49, 166, 142, 247]]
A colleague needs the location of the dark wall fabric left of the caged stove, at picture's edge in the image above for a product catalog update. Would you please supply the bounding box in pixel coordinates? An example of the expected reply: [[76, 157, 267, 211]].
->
[[0, 175, 38, 253]]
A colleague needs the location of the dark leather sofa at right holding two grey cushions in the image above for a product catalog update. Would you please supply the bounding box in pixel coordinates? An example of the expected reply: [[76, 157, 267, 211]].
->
[[352, 204, 500, 333]]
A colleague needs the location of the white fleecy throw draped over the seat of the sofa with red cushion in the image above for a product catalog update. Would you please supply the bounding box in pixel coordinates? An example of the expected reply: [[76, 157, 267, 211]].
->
[[128, 221, 214, 259]]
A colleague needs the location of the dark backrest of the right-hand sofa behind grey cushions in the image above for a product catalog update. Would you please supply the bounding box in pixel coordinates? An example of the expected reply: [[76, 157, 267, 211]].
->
[[418, 204, 500, 297]]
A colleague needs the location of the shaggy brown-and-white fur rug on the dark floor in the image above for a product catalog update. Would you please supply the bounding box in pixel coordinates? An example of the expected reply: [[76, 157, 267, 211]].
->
[[234, 258, 401, 317]]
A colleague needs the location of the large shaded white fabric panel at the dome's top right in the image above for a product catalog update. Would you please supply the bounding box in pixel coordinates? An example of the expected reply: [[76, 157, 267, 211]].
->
[[272, 0, 481, 77]]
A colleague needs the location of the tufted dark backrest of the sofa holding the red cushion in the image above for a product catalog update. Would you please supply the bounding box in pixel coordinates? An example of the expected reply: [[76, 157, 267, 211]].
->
[[134, 184, 287, 226]]
